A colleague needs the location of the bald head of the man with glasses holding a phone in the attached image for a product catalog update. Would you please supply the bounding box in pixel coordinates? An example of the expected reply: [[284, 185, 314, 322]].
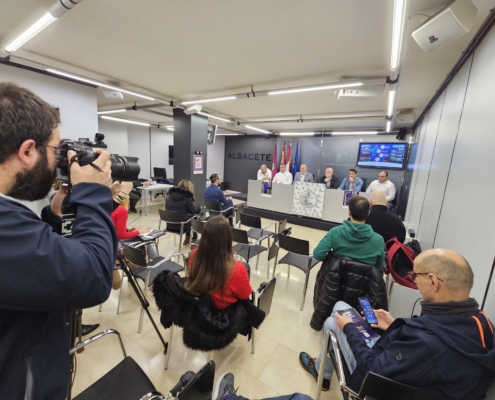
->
[[414, 249, 474, 292]]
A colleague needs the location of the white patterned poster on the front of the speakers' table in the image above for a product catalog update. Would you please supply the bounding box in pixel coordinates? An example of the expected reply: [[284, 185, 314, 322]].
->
[[292, 182, 325, 219]]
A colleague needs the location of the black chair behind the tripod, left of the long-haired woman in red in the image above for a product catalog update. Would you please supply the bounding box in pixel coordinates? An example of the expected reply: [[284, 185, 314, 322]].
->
[[122, 244, 186, 333]]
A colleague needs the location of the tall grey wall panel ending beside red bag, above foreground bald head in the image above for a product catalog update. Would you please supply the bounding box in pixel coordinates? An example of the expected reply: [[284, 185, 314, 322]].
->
[[418, 60, 471, 250]]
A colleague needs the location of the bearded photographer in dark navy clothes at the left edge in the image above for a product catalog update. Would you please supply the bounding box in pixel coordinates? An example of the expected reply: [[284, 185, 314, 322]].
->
[[0, 83, 117, 400]]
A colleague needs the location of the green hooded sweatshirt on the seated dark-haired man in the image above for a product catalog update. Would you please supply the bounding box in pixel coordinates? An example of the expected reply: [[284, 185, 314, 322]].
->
[[313, 221, 385, 268]]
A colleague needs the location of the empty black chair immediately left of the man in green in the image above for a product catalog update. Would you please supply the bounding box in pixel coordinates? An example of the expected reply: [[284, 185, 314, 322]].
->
[[273, 234, 320, 311]]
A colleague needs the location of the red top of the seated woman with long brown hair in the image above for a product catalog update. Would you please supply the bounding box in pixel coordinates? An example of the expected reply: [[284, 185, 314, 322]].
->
[[187, 250, 253, 309]]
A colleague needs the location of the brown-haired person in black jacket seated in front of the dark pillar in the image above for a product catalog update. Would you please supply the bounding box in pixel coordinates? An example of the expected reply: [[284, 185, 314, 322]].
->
[[165, 179, 201, 246]]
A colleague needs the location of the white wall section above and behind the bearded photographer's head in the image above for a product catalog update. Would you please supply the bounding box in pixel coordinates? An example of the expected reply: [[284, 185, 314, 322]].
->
[[0, 64, 98, 140]]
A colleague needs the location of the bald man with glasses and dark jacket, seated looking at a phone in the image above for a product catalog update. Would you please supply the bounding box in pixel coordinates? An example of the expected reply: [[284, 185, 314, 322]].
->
[[302, 249, 495, 400]]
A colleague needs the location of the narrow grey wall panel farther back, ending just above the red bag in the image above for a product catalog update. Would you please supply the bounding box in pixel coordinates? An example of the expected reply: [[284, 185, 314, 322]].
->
[[407, 92, 445, 234]]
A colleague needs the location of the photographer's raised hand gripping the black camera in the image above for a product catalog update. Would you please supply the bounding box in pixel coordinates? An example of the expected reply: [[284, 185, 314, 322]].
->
[[67, 149, 112, 186]]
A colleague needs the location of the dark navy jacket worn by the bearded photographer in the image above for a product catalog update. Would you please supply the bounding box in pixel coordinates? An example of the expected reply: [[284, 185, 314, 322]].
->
[[0, 183, 117, 400]]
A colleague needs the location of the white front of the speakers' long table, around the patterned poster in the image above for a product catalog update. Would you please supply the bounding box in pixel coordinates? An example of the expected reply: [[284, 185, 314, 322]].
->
[[247, 180, 370, 224]]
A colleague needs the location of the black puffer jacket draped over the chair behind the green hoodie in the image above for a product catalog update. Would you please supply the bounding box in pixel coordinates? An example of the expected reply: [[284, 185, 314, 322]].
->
[[310, 253, 388, 331]]
